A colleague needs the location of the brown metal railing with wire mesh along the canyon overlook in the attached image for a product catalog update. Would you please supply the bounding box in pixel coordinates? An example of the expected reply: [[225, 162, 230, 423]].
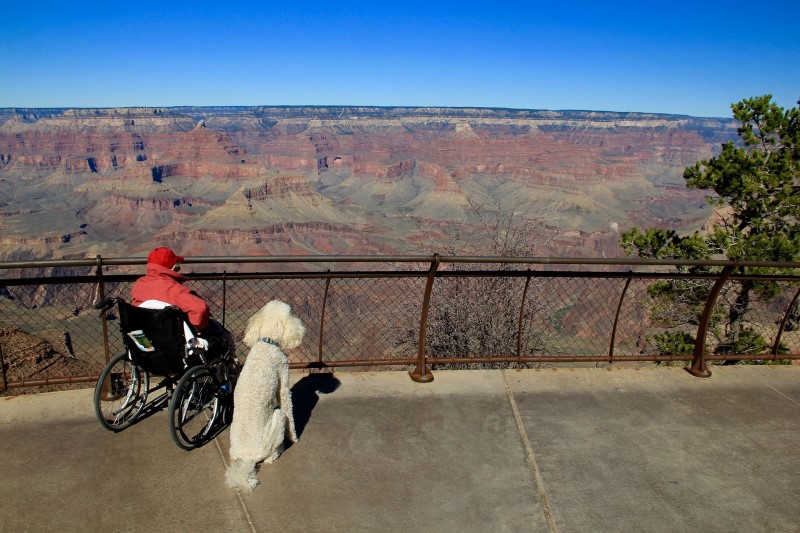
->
[[0, 254, 800, 390]]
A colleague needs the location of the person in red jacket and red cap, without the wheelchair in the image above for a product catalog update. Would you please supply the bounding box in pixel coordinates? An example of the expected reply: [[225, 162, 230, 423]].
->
[[131, 246, 234, 355]]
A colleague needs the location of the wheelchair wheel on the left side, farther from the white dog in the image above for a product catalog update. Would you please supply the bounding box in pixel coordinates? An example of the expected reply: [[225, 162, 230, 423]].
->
[[94, 352, 150, 431]]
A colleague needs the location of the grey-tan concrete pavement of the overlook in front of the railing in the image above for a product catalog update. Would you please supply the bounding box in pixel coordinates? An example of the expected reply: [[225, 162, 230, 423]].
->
[[0, 366, 800, 532]]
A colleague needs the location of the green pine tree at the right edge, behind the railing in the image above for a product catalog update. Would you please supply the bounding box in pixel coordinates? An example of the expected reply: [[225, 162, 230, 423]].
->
[[620, 95, 800, 354]]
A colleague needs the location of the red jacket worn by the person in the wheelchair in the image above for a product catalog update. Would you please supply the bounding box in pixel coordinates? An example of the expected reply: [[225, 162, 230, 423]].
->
[[131, 263, 211, 330]]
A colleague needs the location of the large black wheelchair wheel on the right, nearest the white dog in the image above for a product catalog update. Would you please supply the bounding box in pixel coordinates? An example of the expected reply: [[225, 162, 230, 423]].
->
[[169, 365, 220, 450]]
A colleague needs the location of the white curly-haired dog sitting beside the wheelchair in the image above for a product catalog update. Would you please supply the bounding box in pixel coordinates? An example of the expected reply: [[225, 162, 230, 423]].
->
[[225, 300, 306, 492]]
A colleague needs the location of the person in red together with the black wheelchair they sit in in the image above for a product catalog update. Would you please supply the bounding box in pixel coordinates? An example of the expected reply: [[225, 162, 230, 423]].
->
[[94, 247, 242, 450]]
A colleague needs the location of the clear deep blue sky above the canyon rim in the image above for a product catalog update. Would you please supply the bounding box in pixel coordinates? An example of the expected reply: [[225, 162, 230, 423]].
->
[[0, 0, 800, 117]]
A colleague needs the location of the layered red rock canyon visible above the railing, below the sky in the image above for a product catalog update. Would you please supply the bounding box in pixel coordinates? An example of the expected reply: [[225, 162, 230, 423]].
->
[[0, 107, 737, 261]]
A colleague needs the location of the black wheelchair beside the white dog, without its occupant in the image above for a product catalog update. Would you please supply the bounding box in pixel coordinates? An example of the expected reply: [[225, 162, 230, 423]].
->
[[94, 298, 240, 450]]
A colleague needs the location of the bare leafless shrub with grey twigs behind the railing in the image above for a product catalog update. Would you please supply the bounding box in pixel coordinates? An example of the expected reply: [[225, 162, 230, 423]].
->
[[395, 199, 558, 368]]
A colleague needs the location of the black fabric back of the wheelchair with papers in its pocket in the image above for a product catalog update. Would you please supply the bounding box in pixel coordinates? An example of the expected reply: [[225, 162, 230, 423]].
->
[[118, 300, 195, 376]]
